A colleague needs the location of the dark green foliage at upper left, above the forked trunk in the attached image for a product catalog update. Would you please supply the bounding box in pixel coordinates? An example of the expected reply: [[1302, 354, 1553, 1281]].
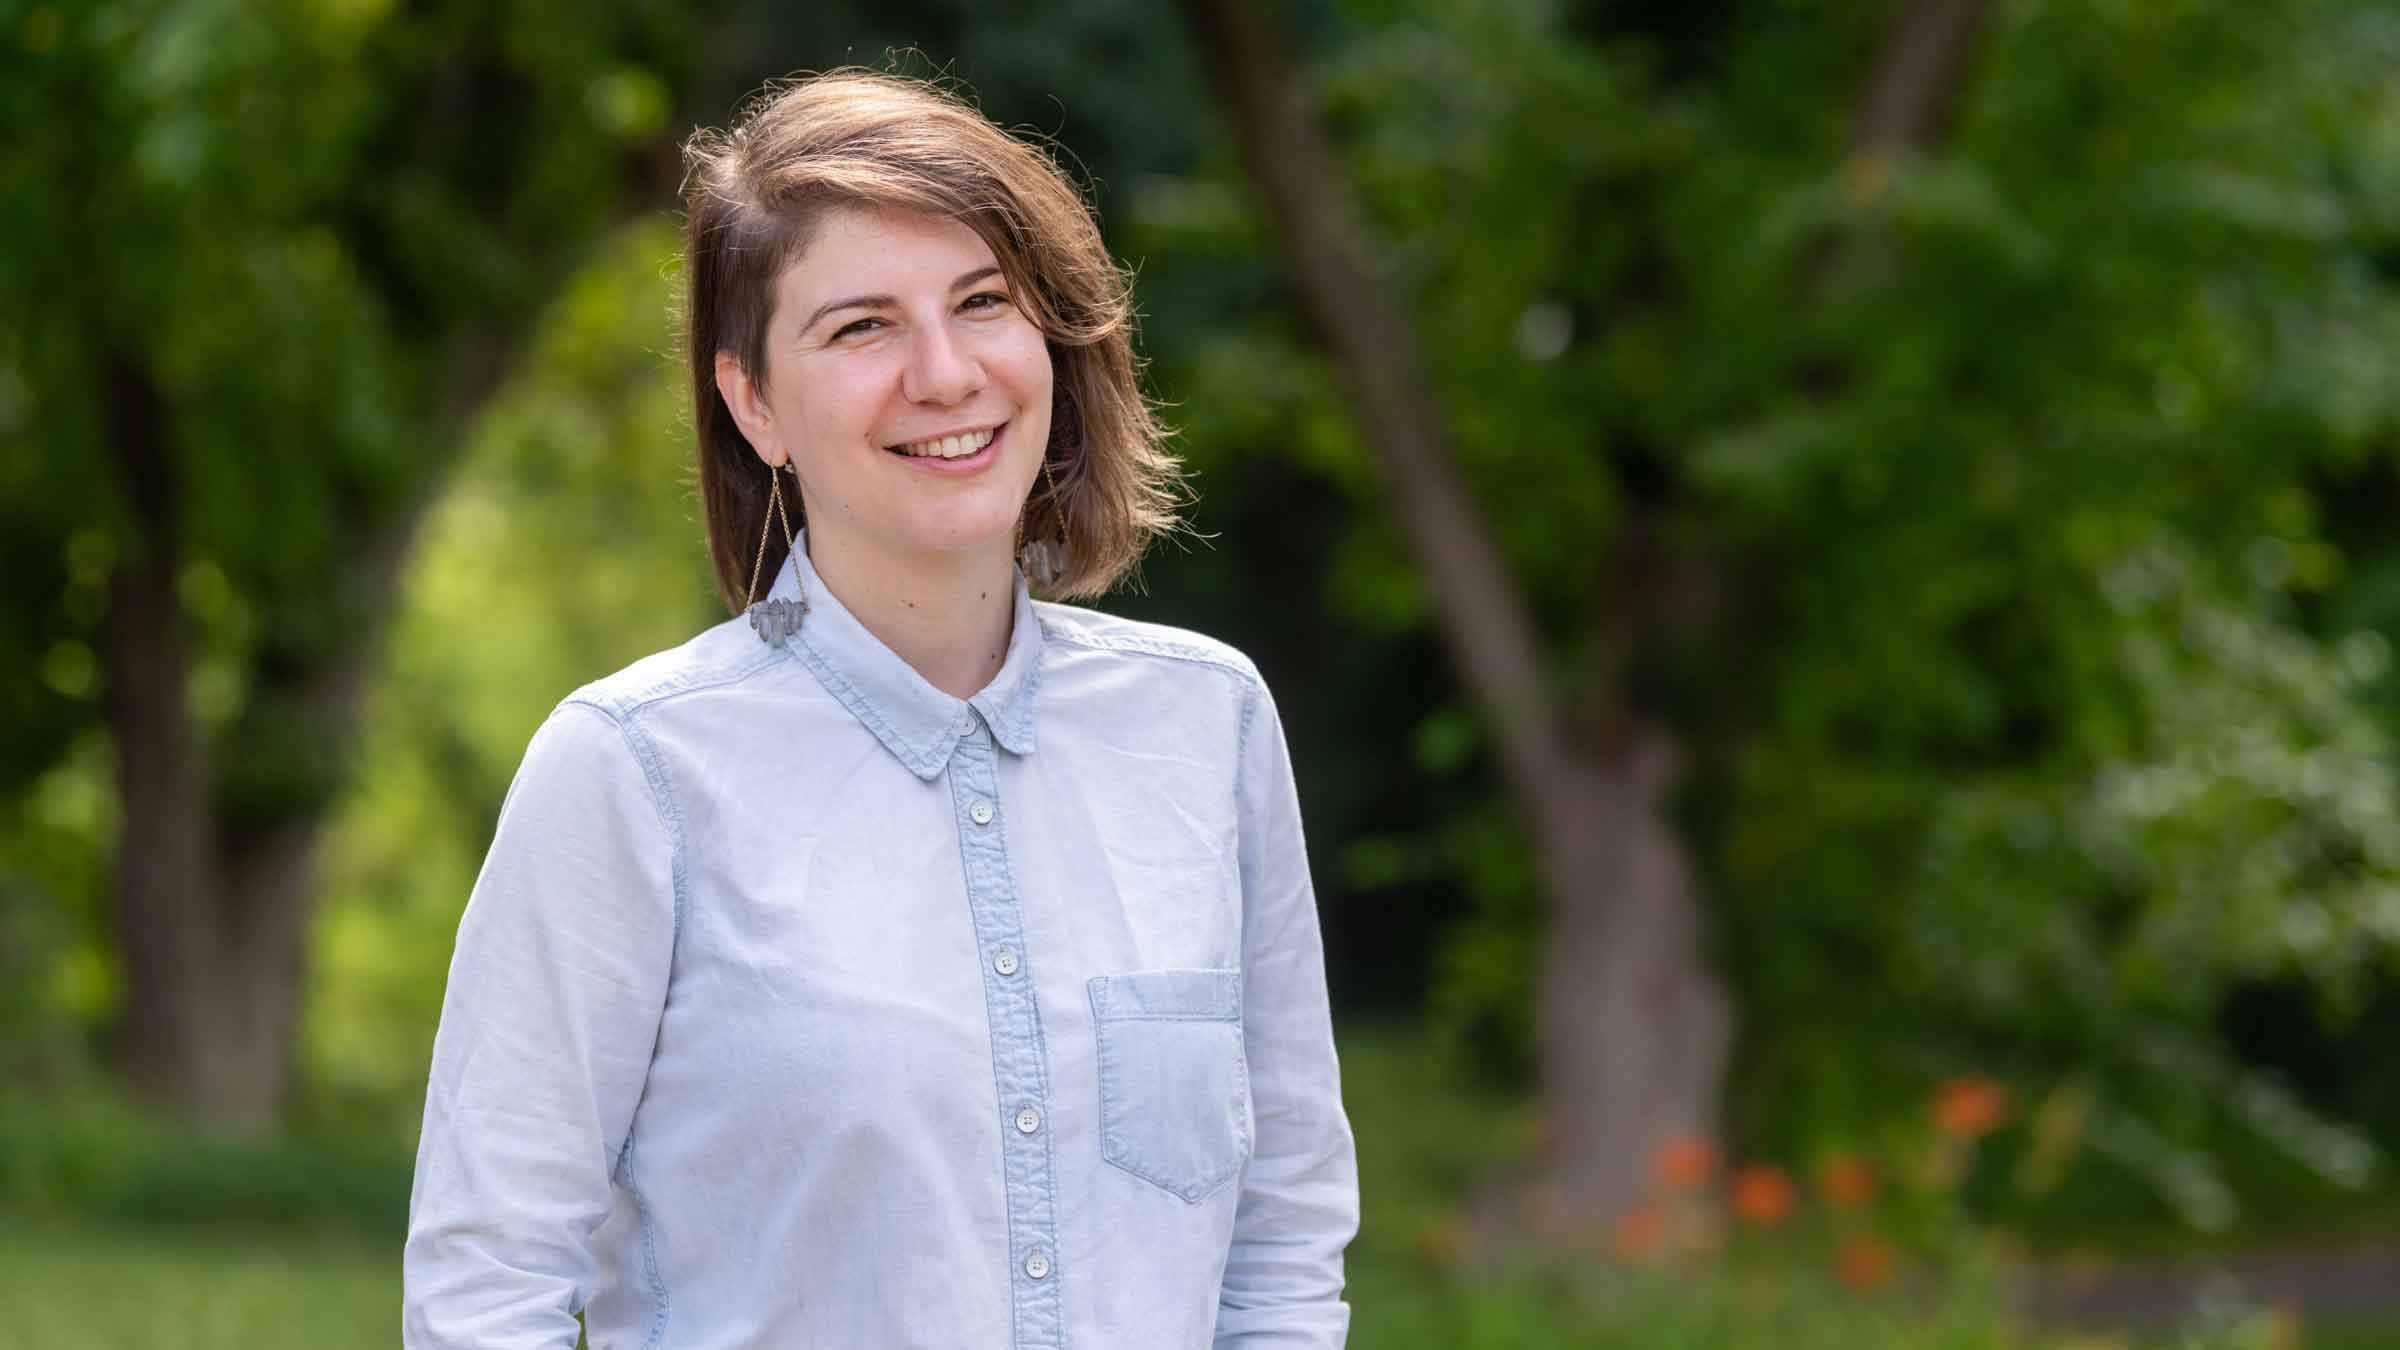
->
[[0, 0, 682, 797]]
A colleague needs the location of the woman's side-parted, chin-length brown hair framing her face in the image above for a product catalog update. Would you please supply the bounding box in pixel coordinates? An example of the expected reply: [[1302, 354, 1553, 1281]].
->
[[684, 67, 1183, 613]]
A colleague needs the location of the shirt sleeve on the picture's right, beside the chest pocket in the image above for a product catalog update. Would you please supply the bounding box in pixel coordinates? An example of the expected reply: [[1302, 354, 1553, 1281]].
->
[[1217, 687, 1358, 1350]]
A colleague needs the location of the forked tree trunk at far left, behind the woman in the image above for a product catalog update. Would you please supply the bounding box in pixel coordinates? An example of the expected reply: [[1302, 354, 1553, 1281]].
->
[[106, 343, 482, 1134]]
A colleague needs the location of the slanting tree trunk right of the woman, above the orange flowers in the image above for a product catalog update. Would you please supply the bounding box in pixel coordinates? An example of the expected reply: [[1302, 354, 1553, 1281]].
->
[[1186, 0, 1733, 1235]]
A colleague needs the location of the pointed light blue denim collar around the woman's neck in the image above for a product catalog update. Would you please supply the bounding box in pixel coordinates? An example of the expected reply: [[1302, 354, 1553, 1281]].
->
[[766, 531, 1042, 778]]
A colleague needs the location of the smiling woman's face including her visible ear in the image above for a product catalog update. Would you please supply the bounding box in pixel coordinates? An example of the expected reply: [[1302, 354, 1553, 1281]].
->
[[718, 209, 1051, 565]]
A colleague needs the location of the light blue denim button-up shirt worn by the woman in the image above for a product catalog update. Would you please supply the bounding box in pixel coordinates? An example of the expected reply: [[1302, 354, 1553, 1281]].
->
[[403, 530, 1358, 1350]]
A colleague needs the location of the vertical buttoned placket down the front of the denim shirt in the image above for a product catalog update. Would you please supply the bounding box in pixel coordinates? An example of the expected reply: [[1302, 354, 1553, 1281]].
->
[[948, 709, 1066, 1350]]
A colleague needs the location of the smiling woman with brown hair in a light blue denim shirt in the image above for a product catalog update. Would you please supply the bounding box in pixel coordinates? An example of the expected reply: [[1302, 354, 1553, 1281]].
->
[[403, 72, 1358, 1350]]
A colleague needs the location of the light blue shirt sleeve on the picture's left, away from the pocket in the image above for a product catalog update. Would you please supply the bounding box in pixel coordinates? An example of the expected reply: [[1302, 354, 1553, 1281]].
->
[[401, 701, 677, 1350]]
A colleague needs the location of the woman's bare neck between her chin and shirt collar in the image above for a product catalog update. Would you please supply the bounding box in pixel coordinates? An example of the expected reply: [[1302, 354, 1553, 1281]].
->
[[809, 528, 1015, 699]]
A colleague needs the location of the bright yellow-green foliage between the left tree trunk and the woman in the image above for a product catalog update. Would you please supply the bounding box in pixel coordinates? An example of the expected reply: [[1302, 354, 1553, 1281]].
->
[[300, 219, 725, 1124]]
